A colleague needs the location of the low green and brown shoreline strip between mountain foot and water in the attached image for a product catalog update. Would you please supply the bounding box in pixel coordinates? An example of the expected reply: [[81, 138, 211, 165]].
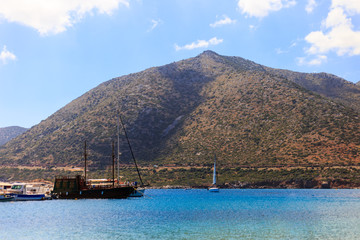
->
[[0, 166, 360, 189]]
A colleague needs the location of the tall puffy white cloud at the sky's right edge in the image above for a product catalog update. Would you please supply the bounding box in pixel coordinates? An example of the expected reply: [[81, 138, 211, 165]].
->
[[305, 0, 360, 56]]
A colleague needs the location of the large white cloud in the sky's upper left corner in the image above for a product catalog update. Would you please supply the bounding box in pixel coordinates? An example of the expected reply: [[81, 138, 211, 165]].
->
[[0, 0, 129, 35]]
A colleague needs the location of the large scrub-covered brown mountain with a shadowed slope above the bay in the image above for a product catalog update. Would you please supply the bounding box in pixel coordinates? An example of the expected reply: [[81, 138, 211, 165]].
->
[[0, 51, 360, 169]]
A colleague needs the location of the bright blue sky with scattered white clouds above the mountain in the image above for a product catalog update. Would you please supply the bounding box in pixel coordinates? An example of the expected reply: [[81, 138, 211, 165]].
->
[[0, 0, 360, 128]]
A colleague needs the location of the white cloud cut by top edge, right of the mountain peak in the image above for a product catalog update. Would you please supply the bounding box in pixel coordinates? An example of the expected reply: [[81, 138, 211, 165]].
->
[[238, 0, 296, 18]]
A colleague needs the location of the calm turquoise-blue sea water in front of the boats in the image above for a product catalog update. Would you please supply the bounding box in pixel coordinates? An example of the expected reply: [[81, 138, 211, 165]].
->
[[0, 189, 360, 240]]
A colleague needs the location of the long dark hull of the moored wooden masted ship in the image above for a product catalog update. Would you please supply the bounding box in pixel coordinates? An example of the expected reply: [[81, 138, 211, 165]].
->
[[53, 187, 134, 199]]
